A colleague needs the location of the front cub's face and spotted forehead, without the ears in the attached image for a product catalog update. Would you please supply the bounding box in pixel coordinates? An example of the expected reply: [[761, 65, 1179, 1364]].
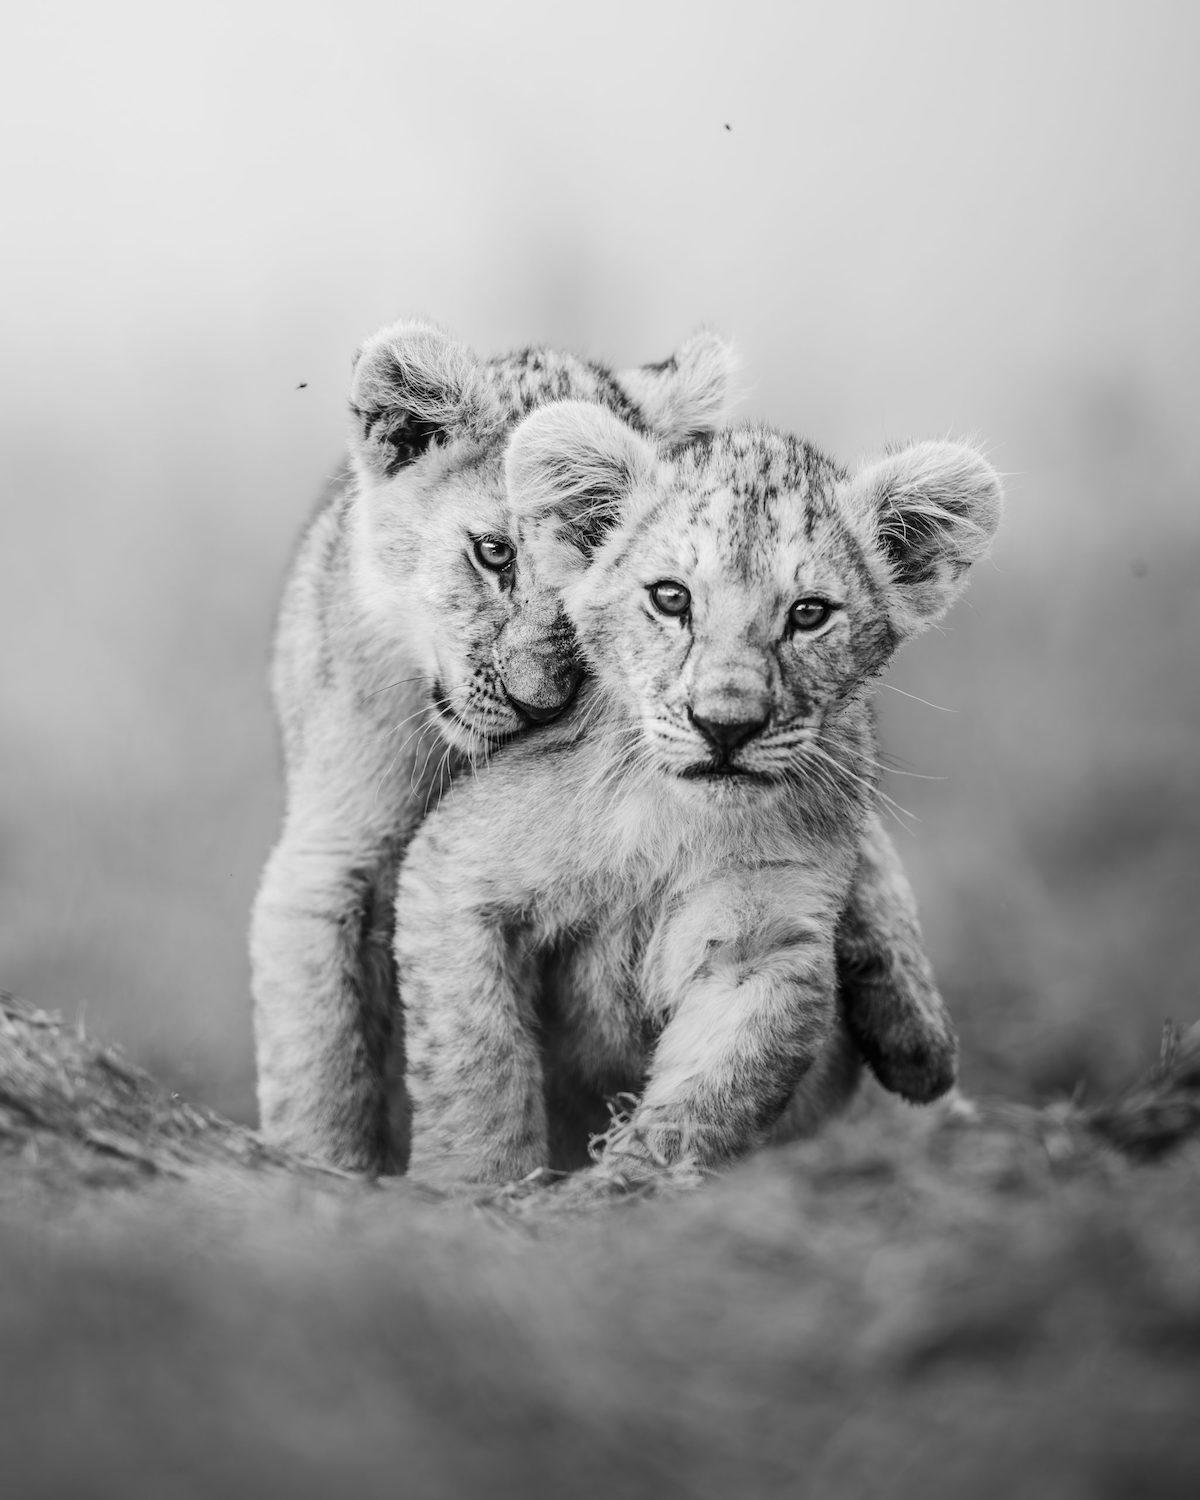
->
[[567, 431, 894, 783]]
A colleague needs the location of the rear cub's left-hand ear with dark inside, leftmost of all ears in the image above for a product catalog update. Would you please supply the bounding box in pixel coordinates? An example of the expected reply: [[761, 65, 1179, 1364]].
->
[[350, 323, 495, 479]]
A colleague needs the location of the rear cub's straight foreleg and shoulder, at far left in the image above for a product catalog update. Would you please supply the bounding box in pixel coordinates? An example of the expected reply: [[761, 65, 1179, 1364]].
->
[[251, 489, 443, 1172]]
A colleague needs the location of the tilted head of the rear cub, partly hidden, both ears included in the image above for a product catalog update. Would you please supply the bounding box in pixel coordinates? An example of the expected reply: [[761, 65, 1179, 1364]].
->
[[350, 323, 732, 753]]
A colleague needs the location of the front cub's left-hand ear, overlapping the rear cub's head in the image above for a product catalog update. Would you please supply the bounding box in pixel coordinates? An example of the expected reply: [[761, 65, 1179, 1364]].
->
[[504, 401, 659, 561]]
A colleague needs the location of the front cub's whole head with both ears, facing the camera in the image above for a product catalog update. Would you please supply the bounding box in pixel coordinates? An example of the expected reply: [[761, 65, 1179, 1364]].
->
[[507, 404, 1001, 789]]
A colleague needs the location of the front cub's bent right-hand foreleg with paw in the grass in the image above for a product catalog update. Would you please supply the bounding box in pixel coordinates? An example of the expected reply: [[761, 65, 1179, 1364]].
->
[[600, 882, 854, 1170]]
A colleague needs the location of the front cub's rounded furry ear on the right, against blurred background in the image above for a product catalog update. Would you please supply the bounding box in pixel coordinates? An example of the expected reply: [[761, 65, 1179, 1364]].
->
[[846, 443, 1002, 638]]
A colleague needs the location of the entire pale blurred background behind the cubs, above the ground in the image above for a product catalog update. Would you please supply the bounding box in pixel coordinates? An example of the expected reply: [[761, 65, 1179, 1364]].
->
[[0, 0, 1200, 1119]]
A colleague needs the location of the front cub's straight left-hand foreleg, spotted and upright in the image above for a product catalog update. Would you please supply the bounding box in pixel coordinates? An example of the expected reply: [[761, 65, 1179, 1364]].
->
[[396, 858, 549, 1182]]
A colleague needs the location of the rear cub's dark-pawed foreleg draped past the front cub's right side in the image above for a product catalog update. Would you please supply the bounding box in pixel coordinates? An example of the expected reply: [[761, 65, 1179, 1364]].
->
[[837, 816, 959, 1104]]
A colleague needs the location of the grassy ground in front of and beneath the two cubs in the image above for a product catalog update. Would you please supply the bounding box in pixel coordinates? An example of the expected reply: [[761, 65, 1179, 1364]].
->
[[0, 998, 1200, 1500]]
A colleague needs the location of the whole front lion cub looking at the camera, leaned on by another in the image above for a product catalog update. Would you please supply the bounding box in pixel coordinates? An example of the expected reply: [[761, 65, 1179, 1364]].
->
[[396, 402, 1001, 1181]]
